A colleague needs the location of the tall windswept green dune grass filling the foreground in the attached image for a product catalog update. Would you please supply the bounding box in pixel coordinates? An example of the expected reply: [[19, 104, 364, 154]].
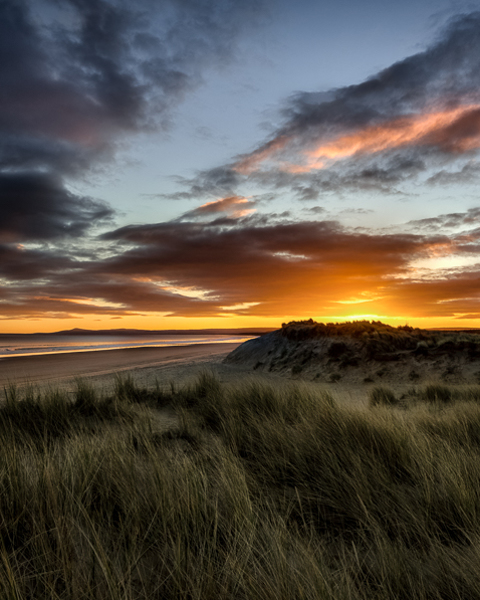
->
[[0, 374, 480, 600]]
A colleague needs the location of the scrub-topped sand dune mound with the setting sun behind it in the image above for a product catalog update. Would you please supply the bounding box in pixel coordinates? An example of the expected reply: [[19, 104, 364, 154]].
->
[[225, 319, 480, 383]]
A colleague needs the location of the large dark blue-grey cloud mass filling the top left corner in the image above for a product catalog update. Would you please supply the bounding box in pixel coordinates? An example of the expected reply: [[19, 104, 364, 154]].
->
[[0, 0, 263, 173]]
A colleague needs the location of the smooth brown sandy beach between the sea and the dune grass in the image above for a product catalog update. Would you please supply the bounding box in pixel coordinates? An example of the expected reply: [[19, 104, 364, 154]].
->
[[0, 343, 371, 406]]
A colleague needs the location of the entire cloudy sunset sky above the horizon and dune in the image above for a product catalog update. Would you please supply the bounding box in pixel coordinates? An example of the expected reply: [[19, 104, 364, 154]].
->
[[0, 0, 480, 333]]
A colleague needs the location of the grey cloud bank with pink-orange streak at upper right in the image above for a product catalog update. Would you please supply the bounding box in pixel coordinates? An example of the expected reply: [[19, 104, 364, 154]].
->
[[172, 12, 480, 200]]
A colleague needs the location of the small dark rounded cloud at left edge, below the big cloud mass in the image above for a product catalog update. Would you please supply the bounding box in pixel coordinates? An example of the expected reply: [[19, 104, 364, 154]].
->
[[0, 173, 112, 242]]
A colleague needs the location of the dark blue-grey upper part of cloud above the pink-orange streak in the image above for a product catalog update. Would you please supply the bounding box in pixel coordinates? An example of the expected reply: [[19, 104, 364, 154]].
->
[[278, 12, 480, 138]]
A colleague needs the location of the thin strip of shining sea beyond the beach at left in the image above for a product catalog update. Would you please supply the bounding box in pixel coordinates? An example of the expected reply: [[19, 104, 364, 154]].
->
[[0, 334, 255, 359]]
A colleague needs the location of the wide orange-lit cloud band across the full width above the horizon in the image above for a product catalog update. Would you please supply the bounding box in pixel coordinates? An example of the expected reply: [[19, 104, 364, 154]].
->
[[0, 211, 480, 320]]
